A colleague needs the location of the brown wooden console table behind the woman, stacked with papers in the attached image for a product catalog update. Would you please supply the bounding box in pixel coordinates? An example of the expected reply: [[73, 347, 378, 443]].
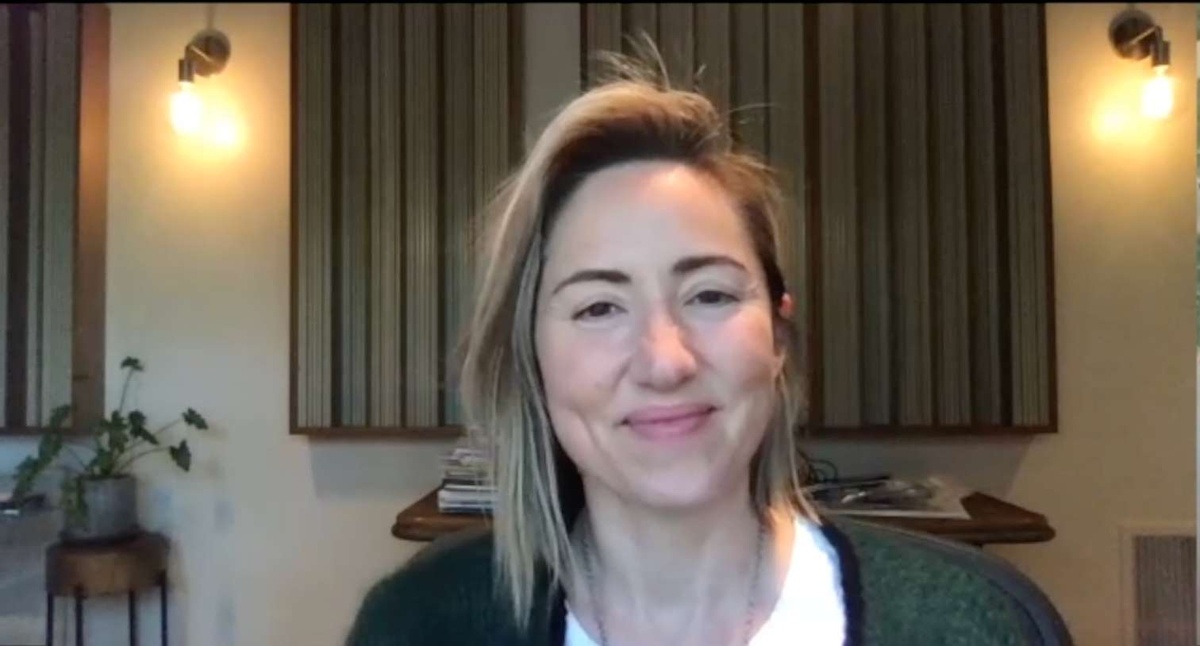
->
[[391, 489, 1055, 546]]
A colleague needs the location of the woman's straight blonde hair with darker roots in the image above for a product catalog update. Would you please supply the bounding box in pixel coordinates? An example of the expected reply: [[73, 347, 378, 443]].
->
[[460, 46, 816, 626]]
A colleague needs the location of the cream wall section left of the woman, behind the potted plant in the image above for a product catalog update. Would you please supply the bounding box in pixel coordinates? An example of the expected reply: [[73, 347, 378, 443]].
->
[[89, 4, 451, 646]]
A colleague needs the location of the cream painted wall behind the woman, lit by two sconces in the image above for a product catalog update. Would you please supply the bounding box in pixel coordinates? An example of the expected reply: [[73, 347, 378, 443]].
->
[[0, 4, 1196, 646]]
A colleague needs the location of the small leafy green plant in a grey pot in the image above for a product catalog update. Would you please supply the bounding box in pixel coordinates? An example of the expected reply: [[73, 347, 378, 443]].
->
[[12, 357, 209, 542]]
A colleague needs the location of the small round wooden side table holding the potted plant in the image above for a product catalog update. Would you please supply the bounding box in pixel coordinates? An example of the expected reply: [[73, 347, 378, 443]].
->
[[46, 533, 168, 646]]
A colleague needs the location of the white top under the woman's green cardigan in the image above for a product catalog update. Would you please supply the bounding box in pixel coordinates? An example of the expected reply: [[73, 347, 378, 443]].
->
[[565, 518, 846, 646]]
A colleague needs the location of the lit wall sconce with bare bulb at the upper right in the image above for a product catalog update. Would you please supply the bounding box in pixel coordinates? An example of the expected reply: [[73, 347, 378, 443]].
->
[[1109, 10, 1175, 119]]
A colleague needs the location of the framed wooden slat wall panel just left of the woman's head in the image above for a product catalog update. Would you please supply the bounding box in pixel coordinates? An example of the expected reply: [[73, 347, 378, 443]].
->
[[293, 4, 520, 432]]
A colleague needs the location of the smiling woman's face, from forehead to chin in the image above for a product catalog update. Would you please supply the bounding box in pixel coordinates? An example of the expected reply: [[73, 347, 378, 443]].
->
[[536, 161, 784, 508]]
